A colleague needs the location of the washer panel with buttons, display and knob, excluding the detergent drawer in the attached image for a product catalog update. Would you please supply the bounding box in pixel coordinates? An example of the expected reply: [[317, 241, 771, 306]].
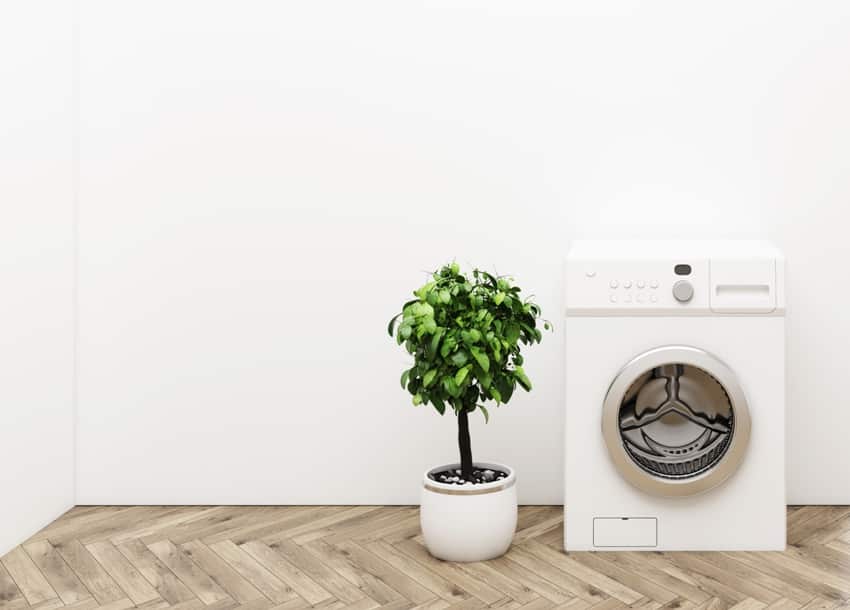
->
[[567, 260, 709, 314]]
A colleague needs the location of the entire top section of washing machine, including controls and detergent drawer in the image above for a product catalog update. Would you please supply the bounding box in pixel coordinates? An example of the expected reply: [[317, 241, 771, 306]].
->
[[566, 240, 785, 316]]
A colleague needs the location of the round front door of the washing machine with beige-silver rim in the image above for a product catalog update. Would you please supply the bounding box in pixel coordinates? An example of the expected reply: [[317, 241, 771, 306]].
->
[[602, 345, 750, 496]]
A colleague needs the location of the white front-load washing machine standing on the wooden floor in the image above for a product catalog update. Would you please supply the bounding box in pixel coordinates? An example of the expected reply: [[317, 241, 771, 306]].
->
[[564, 241, 785, 551]]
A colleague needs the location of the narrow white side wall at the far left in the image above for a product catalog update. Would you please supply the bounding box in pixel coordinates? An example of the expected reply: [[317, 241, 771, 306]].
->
[[0, 0, 74, 556]]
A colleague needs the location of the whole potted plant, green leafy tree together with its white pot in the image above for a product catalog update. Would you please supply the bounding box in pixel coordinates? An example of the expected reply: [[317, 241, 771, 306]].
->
[[388, 263, 549, 561]]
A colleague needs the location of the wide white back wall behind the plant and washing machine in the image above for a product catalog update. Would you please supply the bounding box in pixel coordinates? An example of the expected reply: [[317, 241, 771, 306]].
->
[[78, 0, 850, 503]]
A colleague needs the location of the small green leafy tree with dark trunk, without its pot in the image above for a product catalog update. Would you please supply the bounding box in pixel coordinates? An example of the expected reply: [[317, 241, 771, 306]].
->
[[387, 263, 550, 481]]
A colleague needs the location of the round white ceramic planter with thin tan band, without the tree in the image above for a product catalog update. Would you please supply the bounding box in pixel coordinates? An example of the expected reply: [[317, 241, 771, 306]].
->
[[419, 462, 517, 561]]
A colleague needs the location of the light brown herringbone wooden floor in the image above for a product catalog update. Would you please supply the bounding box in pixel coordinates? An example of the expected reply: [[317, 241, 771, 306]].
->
[[0, 506, 850, 610]]
